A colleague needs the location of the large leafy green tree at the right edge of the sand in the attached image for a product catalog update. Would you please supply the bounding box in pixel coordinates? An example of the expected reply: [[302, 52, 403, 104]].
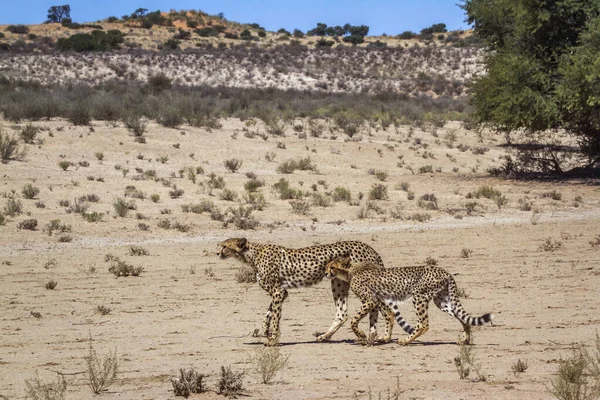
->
[[462, 0, 600, 173]]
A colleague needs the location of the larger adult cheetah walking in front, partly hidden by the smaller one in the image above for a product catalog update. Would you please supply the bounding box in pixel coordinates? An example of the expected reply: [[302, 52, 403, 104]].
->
[[218, 238, 383, 346]]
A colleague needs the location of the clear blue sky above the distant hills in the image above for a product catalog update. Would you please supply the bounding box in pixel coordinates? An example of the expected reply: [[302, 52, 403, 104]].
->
[[0, 0, 468, 35]]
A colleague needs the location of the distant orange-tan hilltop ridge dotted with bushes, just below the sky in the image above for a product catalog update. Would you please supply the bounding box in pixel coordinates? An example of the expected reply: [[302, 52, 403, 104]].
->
[[0, 10, 476, 52]]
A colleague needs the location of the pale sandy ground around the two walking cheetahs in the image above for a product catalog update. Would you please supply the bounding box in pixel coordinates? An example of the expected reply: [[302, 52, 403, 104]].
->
[[0, 120, 600, 399]]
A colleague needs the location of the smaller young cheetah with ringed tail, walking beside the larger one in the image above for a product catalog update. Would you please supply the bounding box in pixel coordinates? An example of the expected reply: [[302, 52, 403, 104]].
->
[[326, 257, 493, 345]]
